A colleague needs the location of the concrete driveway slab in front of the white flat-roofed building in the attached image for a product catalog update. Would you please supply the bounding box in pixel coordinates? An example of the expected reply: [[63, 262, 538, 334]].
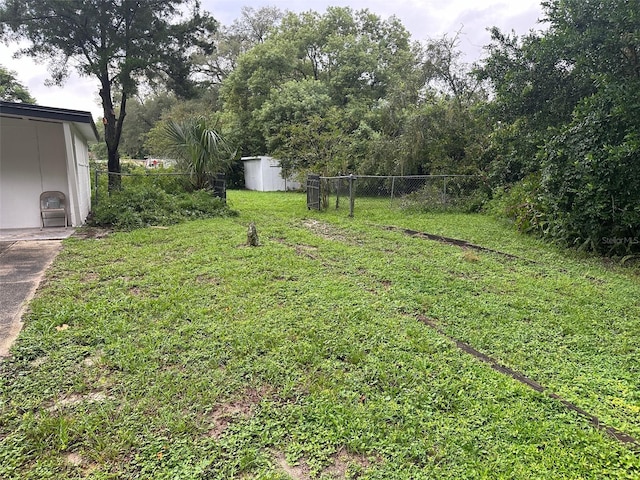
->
[[0, 229, 74, 357]]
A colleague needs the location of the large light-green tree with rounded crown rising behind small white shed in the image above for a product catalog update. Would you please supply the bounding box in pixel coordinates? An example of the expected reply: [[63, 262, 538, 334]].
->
[[221, 7, 419, 169]]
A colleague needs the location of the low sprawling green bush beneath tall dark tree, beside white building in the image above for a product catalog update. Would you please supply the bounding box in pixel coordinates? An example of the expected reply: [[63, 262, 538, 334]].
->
[[89, 185, 237, 230]]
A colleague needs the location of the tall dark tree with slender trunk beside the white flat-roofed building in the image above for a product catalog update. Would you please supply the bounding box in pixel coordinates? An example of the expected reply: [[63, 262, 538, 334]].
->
[[0, 0, 216, 188]]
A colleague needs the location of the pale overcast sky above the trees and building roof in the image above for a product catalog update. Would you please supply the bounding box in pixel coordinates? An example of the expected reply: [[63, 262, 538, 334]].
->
[[0, 0, 542, 117]]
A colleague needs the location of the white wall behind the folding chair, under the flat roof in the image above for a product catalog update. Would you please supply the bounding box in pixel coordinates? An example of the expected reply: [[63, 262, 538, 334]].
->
[[0, 117, 68, 228]]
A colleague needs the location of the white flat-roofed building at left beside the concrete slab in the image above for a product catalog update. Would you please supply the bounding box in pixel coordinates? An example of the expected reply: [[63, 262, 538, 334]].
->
[[0, 101, 98, 229]]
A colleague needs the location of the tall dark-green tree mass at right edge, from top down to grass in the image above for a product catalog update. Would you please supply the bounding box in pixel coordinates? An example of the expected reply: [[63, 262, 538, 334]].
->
[[480, 0, 640, 253]]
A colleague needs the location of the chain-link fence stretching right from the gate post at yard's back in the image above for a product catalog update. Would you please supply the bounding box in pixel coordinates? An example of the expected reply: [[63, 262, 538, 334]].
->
[[310, 175, 485, 216]]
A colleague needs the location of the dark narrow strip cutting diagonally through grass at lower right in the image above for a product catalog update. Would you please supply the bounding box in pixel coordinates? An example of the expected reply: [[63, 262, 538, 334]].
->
[[417, 315, 640, 451]]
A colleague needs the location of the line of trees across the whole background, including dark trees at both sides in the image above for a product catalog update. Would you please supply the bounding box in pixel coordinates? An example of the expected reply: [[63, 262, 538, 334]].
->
[[0, 0, 640, 253]]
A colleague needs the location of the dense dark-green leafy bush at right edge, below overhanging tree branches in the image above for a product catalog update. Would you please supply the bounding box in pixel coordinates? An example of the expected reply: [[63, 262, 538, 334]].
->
[[540, 82, 640, 255]]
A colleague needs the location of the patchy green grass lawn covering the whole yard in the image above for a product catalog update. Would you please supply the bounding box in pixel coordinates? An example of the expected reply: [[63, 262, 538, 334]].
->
[[0, 192, 640, 479]]
